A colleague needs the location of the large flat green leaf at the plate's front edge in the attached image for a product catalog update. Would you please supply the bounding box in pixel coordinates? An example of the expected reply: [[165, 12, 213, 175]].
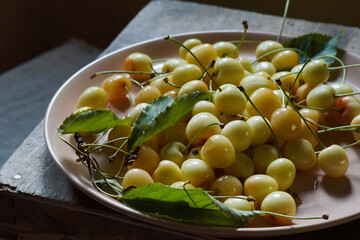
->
[[121, 183, 264, 227]]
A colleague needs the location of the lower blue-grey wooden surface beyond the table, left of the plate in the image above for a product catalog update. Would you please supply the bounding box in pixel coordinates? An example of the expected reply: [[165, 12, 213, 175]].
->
[[0, 39, 101, 166]]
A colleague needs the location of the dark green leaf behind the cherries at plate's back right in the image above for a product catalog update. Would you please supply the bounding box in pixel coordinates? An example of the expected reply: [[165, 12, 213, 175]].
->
[[283, 33, 341, 64]]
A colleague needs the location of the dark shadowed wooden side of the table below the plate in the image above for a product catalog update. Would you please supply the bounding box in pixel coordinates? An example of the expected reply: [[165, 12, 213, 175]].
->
[[0, 192, 206, 240]]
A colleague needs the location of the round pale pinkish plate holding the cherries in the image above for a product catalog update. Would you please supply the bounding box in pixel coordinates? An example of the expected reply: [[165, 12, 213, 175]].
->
[[45, 31, 360, 237]]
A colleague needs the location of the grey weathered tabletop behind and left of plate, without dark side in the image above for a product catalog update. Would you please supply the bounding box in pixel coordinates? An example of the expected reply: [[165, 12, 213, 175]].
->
[[0, 0, 360, 239]]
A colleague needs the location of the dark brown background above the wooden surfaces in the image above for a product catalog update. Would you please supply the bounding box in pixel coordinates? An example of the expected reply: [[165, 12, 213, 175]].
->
[[0, 0, 360, 73]]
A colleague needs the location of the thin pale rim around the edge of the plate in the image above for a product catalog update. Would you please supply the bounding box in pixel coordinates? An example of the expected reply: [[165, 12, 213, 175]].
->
[[43, 30, 360, 237]]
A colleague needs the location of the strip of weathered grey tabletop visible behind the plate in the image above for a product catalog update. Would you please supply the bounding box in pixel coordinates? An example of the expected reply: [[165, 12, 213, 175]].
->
[[103, 0, 360, 55]]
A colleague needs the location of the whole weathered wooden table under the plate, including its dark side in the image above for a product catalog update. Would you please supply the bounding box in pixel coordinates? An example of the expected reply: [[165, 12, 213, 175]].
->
[[0, 0, 360, 239]]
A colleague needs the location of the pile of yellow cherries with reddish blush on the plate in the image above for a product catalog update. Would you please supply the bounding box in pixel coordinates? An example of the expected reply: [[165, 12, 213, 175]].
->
[[74, 39, 360, 225]]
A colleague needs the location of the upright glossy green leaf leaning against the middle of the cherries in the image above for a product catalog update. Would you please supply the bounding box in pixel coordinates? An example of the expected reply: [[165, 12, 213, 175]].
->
[[127, 91, 212, 152]]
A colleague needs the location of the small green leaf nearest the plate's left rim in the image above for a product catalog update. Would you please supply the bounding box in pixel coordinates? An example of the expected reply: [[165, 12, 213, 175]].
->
[[58, 109, 131, 134]]
